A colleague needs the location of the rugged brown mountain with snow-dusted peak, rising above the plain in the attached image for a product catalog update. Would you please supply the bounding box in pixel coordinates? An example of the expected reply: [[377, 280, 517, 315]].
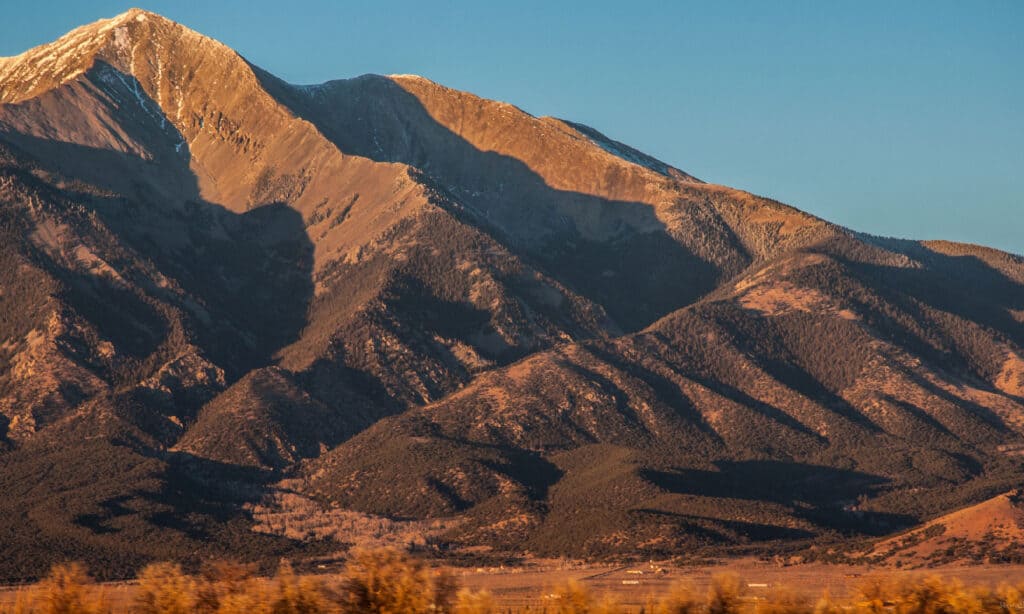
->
[[0, 9, 1024, 578]]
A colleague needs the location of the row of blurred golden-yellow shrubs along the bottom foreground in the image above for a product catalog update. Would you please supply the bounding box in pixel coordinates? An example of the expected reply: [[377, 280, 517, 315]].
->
[[6, 550, 1024, 614]]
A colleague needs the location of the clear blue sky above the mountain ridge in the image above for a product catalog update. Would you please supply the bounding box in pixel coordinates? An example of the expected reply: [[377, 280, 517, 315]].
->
[[0, 0, 1024, 254]]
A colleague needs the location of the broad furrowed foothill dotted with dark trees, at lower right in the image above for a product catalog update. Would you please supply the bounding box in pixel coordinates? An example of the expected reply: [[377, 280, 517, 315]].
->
[[306, 234, 1024, 556]]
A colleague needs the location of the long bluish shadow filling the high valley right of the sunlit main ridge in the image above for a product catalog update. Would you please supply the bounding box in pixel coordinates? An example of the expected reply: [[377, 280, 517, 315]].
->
[[253, 67, 723, 331]]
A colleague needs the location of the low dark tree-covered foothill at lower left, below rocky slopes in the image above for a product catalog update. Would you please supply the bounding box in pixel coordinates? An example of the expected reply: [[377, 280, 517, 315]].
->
[[0, 427, 303, 580]]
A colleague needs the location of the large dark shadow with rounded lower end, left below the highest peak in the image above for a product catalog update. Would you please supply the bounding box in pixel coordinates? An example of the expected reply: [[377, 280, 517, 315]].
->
[[0, 62, 312, 377]]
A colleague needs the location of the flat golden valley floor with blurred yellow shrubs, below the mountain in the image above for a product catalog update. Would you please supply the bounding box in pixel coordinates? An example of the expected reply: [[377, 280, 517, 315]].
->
[[6, 552, 1024, 614]]
